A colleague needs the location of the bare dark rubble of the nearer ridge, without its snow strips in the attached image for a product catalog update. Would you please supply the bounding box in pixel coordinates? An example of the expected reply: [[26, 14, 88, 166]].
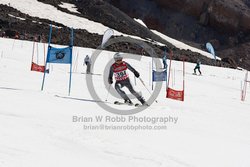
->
[[0, 0, 248, 68]]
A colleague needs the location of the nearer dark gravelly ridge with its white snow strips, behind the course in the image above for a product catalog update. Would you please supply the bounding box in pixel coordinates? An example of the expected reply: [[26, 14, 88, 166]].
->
[[0, 0, 235, 68]]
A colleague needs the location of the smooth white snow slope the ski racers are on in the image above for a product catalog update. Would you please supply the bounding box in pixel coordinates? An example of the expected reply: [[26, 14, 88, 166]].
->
[[0, 38, 250, 167]]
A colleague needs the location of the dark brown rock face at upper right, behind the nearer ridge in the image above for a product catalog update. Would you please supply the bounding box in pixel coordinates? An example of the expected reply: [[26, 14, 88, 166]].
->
[[105, 0, 250, 69]]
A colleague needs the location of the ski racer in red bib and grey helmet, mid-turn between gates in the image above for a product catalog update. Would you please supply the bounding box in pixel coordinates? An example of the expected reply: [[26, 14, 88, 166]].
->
[[108, 53, 147, 105]]
